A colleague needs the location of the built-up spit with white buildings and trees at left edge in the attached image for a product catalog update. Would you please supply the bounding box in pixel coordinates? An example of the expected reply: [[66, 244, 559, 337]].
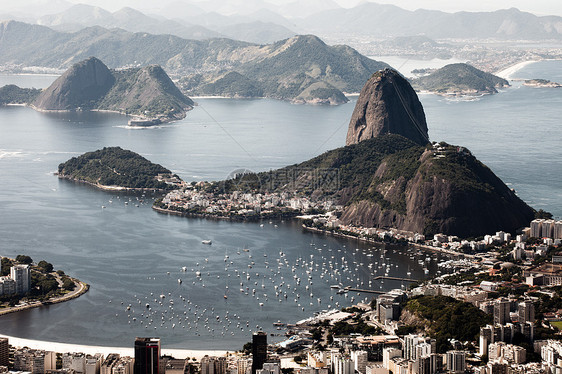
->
[[0, 255, 90, 315]]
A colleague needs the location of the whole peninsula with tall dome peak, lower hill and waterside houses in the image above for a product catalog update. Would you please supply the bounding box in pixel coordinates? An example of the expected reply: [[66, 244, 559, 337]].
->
[[156, 69, 535, 237]]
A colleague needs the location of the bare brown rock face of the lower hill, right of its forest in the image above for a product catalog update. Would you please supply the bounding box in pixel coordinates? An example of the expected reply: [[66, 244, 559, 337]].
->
[[332, 140, 534, 237]]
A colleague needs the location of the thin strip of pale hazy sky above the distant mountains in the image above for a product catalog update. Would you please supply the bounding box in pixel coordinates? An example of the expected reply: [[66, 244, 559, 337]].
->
[[0, 0, 562, 16]]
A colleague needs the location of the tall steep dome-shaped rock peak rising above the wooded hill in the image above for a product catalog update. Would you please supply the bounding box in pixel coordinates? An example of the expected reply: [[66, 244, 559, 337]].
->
[[345, 69, 429, 145]]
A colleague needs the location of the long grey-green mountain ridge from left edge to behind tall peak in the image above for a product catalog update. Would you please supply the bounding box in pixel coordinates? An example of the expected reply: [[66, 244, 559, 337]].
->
[[0, 21, 388, 104]]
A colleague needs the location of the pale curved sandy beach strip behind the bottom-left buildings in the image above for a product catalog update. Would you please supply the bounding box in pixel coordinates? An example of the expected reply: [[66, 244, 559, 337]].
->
[[0, 334, 228, 360]]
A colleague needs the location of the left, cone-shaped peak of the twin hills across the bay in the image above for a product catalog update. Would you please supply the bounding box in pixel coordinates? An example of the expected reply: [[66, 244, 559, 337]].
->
[[33, 57, 115, 110]]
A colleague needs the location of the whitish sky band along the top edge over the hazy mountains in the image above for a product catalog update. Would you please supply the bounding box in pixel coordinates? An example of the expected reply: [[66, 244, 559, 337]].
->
[[0, 0, 562, 16]]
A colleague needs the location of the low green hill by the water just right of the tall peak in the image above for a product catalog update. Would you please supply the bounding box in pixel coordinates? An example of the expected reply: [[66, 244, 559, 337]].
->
[[412, 64, 509, 96]]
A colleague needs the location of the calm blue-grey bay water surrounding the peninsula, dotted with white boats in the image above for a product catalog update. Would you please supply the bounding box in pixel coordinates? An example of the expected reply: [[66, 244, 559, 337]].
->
[[0, 62, 562, 349]]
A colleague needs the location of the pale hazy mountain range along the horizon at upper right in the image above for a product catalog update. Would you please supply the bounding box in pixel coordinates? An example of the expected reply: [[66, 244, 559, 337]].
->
[[297, 2, 562, 40]]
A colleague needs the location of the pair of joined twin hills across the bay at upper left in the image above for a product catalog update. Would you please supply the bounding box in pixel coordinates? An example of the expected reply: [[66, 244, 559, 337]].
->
[[32, 57, 194, 121]]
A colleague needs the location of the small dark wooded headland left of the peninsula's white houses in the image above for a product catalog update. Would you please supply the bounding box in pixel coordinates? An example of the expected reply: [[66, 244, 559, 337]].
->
[[57, 147, 183, 191]]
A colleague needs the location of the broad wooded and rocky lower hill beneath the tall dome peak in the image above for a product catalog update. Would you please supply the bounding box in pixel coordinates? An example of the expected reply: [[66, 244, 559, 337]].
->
[[259, 134, 534, 238]]
